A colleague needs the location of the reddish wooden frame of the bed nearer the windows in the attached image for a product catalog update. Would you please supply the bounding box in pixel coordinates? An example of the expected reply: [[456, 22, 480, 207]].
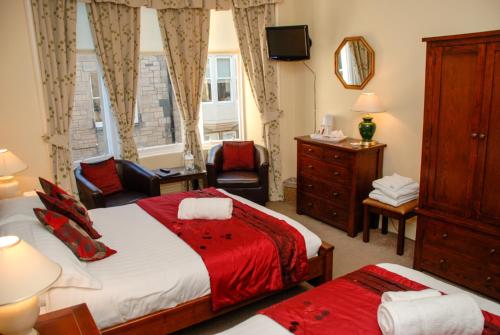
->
[[101, 242, 334, 335]]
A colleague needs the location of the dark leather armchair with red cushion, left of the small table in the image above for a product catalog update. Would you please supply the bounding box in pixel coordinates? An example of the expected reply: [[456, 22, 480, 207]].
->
[[75, 158, 160, 209]]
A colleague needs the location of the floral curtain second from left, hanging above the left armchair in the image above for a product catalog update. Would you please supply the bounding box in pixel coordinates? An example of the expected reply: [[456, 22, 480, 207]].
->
[[87, 1, 141, 162]]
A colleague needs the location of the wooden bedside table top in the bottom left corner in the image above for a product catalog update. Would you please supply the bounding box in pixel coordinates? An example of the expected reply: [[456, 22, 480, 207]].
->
[[35, 304, 101, 335]]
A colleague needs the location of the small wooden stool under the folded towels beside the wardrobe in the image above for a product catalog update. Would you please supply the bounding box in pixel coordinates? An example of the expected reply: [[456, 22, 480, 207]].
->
[[363, 198, 418, 255]]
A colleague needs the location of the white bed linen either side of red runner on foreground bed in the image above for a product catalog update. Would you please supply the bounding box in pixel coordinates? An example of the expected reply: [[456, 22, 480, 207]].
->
[[219, 263, 500, 335]]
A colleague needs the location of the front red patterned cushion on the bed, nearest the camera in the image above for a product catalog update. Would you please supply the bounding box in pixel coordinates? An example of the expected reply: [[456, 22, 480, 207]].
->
[[33, 208, 116, 262]]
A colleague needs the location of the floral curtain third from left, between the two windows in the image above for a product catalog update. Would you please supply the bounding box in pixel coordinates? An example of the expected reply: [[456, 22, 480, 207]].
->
[[158, 8, 210, 167]]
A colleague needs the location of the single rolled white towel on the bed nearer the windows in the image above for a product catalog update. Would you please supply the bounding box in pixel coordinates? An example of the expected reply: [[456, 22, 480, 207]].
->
[[177, 198, 233, 220]]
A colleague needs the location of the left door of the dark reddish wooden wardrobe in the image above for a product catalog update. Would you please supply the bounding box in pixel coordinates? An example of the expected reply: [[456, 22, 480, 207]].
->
[[423, 44, 486, 217]]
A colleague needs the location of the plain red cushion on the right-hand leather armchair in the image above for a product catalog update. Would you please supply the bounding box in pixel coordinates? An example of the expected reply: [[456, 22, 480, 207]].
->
[[222, 141, 255, 171]]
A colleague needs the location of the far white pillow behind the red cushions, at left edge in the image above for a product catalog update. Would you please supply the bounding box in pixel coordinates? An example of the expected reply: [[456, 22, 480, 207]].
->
[[0, 196, 45, 225]]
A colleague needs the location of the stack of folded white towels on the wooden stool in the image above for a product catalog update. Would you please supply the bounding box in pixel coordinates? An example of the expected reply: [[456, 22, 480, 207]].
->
[[368, 173, 419, 207]]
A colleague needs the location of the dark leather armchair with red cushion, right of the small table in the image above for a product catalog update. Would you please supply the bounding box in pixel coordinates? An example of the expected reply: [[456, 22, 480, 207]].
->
[[207, 141, 269, 205]]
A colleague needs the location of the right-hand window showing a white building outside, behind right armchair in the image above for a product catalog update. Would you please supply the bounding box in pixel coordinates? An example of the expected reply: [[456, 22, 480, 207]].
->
[[200, 54, 242, 142]]
